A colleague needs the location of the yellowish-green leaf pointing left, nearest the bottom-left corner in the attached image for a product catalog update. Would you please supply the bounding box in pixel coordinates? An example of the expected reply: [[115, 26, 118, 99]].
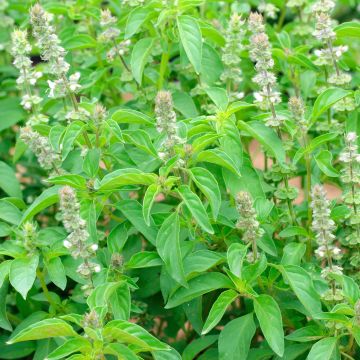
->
[[8, 319, 78, 344]]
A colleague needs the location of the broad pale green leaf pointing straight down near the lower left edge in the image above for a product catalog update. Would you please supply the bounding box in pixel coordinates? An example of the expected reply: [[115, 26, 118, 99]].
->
[[9, 255, 39, 299]]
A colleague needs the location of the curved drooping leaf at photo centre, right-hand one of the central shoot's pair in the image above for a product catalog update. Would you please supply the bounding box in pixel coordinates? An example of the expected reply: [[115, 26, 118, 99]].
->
[[189, 167, 221, 219]]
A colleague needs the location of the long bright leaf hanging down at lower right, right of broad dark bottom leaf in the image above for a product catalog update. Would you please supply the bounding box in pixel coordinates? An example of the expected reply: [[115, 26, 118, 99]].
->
[[254, 295, 284, 356]]
